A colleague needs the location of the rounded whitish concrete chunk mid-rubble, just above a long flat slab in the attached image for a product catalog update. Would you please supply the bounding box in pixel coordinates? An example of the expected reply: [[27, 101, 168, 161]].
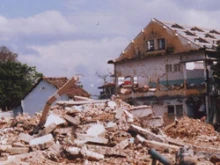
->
[[86, 124, 106, 137]]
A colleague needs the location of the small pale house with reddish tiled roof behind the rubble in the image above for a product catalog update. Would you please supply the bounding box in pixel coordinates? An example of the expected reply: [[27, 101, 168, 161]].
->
[[14, 77, 90, 116]]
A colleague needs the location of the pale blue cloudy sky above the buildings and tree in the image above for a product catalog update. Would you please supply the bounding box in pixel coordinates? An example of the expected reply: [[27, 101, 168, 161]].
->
[[0, 0, 220, 95]]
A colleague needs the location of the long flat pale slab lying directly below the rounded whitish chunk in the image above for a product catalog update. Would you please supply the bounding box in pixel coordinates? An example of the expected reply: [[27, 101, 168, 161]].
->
[[76, 133, 108, 144]]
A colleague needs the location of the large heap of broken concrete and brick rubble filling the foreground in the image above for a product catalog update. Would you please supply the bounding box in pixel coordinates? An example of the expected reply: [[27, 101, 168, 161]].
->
[[0, 99, 220, 165]]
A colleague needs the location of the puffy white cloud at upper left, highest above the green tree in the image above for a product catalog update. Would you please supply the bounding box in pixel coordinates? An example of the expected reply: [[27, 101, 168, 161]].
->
[[0, 10, 75, 39]]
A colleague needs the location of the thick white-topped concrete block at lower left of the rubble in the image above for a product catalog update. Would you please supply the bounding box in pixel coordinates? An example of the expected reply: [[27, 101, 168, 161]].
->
[[29, 134, 54, 150]]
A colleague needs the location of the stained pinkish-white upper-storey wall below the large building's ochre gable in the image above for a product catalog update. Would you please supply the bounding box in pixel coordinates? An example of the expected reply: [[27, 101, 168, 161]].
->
[[115, 55, 204, 87]]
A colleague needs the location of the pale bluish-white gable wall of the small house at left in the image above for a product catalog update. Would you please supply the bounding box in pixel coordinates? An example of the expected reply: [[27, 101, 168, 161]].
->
[[23, 80, 69, 115]]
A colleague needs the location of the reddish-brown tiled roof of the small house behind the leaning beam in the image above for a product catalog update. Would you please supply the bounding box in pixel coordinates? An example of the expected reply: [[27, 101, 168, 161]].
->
[[43, 77, 90, 98]]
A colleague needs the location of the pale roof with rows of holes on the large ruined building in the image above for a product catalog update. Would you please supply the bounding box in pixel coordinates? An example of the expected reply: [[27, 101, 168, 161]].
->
[[108, 18, 220, 64]]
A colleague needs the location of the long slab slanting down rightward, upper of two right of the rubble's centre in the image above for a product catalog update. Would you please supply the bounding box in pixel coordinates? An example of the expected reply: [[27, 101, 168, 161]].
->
[[130, 124, 165, 142]]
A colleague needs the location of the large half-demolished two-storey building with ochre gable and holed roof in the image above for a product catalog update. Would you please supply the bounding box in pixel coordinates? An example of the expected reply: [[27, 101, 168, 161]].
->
[[108, 19, 220, 124]]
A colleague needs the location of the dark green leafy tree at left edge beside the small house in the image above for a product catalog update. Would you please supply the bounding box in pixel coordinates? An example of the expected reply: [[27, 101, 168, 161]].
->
[[0, 47, 42, 110]]
